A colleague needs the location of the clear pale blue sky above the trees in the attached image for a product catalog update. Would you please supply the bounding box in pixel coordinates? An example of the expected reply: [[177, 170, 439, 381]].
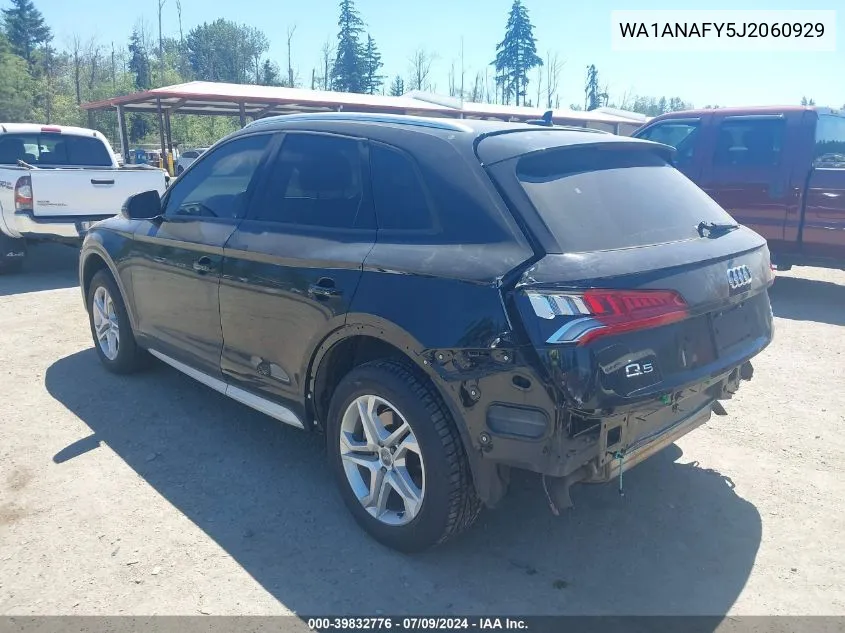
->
[[28, 0, 845, 107]]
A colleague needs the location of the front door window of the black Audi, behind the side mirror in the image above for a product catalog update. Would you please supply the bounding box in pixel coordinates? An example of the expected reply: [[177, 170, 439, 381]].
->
[[165, 134, 271, 218]]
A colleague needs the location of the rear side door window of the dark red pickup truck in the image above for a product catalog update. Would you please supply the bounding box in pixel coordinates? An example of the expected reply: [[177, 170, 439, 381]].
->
[[713, 119, 784, 167]]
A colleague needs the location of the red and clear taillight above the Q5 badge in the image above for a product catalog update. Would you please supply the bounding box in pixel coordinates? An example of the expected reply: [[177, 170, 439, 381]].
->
[[527, 289, 689, 345]]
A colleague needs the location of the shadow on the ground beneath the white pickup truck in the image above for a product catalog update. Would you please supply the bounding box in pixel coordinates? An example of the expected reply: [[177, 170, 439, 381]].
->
[[0, 244, 79, 297]]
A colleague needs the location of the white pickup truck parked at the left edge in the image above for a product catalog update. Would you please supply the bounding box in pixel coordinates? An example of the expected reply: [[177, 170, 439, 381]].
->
[[0, 123, 169, 272]]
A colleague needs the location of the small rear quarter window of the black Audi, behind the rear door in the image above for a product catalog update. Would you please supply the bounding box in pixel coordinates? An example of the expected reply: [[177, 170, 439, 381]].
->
[[370, 144, 434, 231]]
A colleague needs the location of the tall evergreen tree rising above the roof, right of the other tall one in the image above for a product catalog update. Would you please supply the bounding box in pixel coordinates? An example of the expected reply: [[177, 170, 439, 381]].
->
[[491, 0, 543, 105]]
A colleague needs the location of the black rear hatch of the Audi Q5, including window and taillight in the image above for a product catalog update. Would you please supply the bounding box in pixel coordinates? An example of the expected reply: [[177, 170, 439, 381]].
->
[[478, 133, 773, 414]]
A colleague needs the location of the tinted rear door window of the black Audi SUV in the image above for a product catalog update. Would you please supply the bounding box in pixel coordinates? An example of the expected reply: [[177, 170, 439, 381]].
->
[[254, 134, 363, 228]]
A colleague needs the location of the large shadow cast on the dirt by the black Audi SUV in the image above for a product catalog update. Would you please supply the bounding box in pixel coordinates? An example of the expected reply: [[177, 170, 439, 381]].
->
[[46, 349, 761, 615]]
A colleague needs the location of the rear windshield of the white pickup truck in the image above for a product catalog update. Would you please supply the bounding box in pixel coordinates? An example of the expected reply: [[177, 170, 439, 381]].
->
[[0, 133, 112, 167]]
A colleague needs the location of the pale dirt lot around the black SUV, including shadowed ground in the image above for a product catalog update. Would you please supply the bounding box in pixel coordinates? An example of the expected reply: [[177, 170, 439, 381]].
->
[[0, 242, 845, 615]]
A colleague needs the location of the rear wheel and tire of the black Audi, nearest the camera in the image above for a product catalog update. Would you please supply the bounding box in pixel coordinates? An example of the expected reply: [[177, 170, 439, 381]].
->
[[327, 360, 481, 552]]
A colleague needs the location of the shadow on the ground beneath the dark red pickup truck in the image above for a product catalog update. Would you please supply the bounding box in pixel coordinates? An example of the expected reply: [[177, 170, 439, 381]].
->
[[769, 277, 845, 325]]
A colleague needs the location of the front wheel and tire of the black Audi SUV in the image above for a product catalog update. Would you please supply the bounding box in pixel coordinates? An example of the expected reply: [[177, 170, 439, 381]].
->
[[87, 270, 147, 374]]
